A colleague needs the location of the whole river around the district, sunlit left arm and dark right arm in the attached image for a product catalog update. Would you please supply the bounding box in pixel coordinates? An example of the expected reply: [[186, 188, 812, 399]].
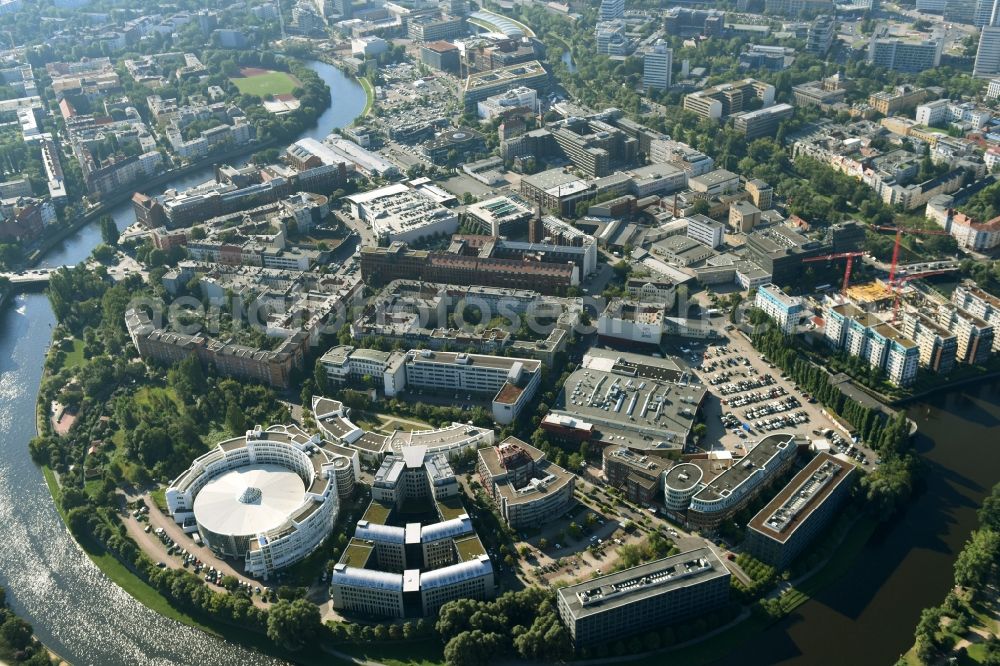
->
[[0, 58, 1000, 666]]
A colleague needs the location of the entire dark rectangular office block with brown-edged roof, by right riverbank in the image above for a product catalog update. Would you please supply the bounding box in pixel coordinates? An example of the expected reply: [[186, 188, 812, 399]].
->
[[743, 453, 855, 571]]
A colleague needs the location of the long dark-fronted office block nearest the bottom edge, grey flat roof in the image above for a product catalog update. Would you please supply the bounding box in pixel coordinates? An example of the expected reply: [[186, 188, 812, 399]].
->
[[557, 548, 730, 647]]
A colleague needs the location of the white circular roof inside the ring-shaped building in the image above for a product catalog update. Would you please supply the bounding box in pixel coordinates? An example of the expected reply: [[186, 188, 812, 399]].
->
[[194, 465, 305, 536]]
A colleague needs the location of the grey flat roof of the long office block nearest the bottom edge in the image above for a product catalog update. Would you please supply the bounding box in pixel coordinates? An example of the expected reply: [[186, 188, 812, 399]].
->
[[557, 548, 730, 620]]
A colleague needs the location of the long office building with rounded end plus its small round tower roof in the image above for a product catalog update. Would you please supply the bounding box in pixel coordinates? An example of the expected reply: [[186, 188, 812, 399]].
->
[[684, 433, 798, 532]]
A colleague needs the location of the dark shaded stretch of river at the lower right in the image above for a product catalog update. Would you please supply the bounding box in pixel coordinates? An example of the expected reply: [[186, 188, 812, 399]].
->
[[720, 384, 1000, 666]]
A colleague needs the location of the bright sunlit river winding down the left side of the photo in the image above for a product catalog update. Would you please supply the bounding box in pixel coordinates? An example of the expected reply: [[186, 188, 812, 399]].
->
[[0, 62, 365, 666]]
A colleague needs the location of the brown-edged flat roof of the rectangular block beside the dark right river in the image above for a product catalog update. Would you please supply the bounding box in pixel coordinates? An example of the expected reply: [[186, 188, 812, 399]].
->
[[747, 453, 854, 543]]
